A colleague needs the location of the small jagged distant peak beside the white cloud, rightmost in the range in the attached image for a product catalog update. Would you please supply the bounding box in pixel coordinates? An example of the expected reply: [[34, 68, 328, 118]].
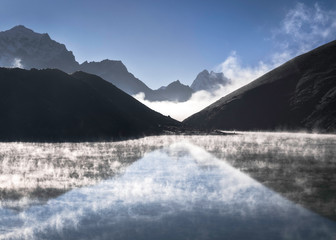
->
[[190, 70, 230, 92]]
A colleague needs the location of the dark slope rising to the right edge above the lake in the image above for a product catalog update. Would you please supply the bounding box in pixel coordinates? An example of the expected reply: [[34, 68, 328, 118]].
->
[[184, 41, 336, 132]]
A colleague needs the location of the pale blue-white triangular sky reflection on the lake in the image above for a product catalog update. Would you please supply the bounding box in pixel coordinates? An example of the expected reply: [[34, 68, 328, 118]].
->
[[0, 142, 336, 239]]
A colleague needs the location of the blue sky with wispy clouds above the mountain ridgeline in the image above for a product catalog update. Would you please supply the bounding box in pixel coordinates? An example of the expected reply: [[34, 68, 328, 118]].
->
[[0, 0, 336, 88]]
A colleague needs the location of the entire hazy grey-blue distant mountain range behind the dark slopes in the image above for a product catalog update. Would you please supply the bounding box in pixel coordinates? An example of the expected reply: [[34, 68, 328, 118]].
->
[[0, 25, 228, 102]]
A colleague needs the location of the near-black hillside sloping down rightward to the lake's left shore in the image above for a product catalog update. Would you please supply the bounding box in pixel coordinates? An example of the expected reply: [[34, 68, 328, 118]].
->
[[0, 68, 180, 141]]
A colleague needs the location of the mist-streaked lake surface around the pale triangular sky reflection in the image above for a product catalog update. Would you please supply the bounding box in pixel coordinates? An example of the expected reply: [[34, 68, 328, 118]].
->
[[0, 132, 336, 220]]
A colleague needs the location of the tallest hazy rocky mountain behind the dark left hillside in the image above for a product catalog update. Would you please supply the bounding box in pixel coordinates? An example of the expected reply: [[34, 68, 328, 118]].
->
[[0, 25, 78, 72]]
